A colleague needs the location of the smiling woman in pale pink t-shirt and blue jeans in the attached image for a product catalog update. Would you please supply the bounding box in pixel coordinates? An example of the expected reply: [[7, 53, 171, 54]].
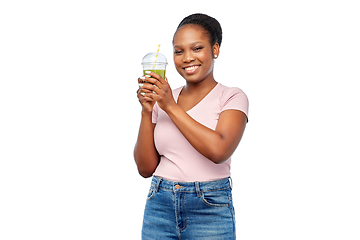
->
[[134, 14, 248, 240]]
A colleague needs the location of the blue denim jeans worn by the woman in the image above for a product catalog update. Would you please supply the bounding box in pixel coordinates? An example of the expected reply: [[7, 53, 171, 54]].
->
[[142, 176, 235, 240]]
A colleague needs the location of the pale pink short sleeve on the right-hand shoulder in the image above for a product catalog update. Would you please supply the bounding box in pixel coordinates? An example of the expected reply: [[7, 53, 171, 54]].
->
[[221, 87, 249, 120]]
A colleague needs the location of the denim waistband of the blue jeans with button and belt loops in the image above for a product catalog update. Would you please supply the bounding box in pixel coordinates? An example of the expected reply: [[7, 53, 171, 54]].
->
[[151, 176, 232, 194]]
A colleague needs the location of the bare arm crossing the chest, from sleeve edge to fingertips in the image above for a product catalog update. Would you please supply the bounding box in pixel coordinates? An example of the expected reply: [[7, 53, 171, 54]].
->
[[139, 73, 247, 164]]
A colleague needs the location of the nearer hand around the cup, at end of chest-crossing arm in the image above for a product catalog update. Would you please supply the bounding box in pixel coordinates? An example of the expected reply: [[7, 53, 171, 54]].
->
[[140, 71, 176, 112]]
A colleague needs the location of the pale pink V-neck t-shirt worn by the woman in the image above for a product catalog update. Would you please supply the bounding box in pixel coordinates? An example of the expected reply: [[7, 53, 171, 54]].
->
[[152, 83, 249, 182]]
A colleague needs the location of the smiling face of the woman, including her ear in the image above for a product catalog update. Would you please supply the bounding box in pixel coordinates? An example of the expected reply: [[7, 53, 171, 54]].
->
[[173, 24, 219, 83]]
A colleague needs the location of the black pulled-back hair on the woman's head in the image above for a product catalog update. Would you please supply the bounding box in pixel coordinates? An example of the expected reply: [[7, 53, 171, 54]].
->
[[174, 13, 222, 46]]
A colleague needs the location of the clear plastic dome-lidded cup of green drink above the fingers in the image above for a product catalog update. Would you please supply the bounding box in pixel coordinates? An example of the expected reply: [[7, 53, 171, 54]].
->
[[141, 52, 167, 79]]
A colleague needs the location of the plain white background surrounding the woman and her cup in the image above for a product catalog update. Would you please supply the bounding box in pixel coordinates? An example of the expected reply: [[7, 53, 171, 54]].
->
[[0, 0, 360, 240]]
